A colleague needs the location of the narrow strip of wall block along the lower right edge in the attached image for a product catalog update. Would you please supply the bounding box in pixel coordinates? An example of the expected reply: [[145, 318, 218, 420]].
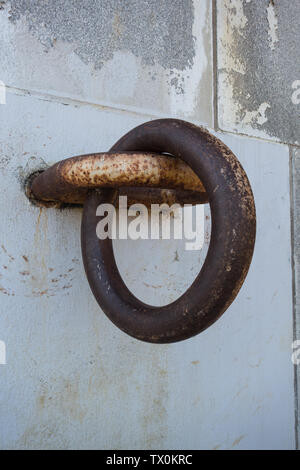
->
[[291, 148, 300, 440]]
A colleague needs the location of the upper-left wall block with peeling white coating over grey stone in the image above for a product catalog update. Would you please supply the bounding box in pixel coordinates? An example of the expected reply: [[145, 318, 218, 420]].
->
[[0, 0, 213, 125]]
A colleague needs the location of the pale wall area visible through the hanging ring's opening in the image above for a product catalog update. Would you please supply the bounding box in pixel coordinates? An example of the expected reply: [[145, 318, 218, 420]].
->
[[113, 204, 211, 307]]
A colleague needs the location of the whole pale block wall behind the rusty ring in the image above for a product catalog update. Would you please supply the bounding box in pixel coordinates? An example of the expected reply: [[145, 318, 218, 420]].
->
[[0, 0, 300, 449]]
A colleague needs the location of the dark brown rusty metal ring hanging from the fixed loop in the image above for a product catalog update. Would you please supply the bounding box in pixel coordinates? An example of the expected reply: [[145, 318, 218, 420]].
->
[[81, 119, 256, 343]]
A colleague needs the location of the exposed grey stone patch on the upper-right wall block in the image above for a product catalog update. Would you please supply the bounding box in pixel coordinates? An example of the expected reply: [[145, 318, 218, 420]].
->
[[222, 0, 300, 143]]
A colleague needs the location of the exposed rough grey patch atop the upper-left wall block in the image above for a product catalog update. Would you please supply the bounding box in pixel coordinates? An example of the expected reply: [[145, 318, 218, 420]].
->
[[10, 0, 195, 70]]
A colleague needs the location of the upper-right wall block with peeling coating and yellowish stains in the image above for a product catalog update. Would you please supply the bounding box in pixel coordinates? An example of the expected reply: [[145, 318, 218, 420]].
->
[[217, 0, 300, 143]]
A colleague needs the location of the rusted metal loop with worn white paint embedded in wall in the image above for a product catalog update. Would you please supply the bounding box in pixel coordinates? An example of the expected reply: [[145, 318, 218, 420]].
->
[[31, 152, 207, 205]]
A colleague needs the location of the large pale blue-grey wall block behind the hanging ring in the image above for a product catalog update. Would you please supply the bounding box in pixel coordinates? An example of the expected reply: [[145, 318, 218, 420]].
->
[[0, 88, 295, 449]]
